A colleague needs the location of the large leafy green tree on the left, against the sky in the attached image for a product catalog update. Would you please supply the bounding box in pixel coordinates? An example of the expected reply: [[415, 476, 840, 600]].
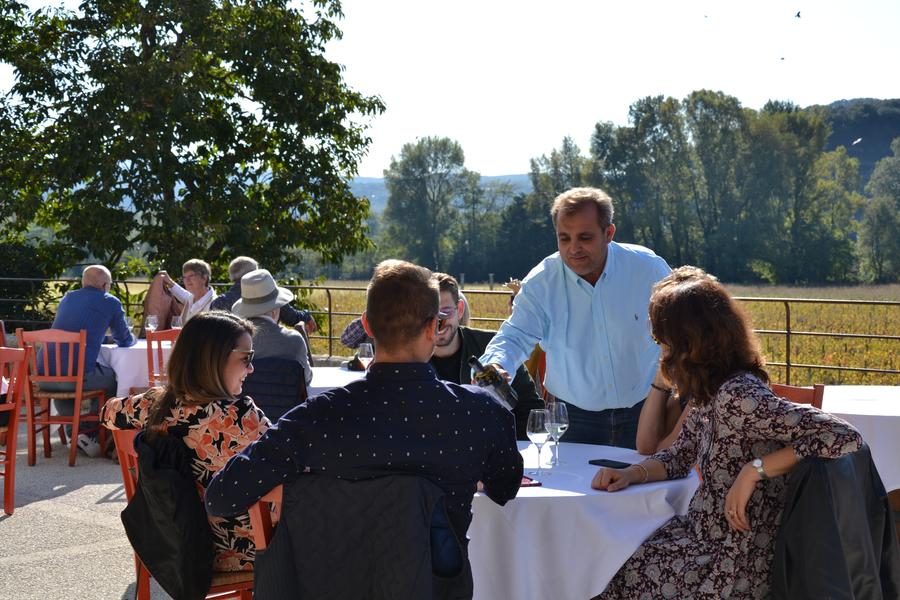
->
[[0, 0, 383, 268]]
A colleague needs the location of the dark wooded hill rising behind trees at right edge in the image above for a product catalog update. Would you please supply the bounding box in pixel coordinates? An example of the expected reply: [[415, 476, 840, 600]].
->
[[824, 98, 900, 187]]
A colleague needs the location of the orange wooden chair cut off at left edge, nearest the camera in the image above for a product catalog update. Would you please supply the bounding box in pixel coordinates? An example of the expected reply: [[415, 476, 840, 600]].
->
[[0, 347, 26, 515]]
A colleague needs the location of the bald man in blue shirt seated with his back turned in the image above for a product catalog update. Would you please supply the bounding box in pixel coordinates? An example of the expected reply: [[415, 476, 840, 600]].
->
[[42, 265, 136, 456]]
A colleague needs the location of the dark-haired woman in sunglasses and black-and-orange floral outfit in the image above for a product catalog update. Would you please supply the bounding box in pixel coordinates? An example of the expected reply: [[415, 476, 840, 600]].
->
[[103, 311, 270, 571]]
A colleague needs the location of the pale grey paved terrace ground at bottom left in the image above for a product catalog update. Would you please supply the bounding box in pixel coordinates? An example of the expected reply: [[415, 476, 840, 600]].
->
[[0, 426, 168, 600]]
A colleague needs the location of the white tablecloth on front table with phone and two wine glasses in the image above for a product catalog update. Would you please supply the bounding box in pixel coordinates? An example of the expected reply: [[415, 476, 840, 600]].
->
[[468, 442, 698, 600]]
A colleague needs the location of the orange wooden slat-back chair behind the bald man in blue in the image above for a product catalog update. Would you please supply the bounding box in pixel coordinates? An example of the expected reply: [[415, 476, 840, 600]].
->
[[16, 328, 106, 467]]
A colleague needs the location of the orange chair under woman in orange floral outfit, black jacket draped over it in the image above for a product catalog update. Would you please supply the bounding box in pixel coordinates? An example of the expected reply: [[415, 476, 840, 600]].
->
[[112, 428, 253, 600]]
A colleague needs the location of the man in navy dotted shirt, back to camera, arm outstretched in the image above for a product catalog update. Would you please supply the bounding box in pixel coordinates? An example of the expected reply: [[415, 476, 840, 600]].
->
[[206, 260, 522, 592]]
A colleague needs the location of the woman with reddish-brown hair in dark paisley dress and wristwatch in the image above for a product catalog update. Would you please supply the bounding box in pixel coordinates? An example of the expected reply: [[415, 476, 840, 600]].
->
[[592, 267, 862, 600]]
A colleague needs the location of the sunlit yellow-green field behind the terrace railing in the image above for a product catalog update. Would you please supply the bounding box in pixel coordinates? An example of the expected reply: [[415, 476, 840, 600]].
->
[[309, 281, 900, 385]]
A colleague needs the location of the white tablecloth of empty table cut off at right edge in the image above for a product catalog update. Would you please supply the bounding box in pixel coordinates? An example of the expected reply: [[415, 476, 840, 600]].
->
[[822, 385, 900, 491]]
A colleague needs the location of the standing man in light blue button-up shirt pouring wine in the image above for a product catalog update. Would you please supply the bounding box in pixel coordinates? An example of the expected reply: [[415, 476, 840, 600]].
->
[[481, 188, 671, 448]]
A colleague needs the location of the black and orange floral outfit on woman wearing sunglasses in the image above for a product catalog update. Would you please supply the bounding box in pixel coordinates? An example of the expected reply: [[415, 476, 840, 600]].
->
[[103, 392, 271, 571]]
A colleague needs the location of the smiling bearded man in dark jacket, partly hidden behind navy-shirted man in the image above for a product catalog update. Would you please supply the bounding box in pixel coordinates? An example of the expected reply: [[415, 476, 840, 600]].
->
[[429, 273, 544, 440]]
